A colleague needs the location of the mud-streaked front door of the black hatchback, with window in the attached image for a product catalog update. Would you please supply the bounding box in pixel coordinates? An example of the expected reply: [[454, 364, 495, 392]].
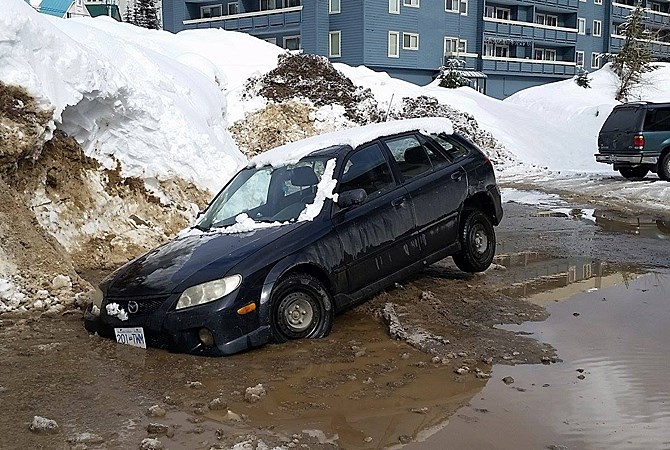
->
[[333, 143, 421, 293]]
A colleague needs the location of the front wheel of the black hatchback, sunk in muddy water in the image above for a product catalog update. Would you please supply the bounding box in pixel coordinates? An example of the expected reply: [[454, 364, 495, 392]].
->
[[270, 273, 334, 343]]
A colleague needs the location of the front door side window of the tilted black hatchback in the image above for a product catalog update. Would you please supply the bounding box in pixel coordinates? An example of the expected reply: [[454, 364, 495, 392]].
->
[[337, 144, 395, 199]]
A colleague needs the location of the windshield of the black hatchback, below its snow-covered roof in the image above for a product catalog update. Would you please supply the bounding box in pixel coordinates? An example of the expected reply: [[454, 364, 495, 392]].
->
[[196, 158, 327, 230]]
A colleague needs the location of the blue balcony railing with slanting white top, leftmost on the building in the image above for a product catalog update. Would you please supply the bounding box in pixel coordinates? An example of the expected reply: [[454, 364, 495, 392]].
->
[[184, 6, 302, 33]]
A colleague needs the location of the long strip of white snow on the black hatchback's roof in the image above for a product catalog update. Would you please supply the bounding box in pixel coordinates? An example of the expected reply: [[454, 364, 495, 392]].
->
[[249, 117, 454, 167]]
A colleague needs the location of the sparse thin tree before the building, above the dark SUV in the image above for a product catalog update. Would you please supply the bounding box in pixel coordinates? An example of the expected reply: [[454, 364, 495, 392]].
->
[[612, 4, 654, 101]]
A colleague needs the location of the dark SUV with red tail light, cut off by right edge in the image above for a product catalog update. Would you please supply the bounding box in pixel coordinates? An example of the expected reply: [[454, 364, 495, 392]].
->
[[595, 102, 670, 181]]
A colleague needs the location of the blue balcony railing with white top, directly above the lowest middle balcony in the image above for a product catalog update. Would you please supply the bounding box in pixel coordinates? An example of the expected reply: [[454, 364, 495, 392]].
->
[[484, 17, 578, 45]]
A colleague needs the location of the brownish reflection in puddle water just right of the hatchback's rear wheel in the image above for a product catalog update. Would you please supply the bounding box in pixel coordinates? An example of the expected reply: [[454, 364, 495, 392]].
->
[[494, 252, 641, 305]]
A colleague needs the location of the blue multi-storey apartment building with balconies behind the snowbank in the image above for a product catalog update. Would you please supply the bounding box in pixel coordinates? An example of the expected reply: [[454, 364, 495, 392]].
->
[[163, 0, 670, 98]]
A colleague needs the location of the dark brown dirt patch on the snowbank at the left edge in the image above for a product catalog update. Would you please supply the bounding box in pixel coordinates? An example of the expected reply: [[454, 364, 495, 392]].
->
[[0, 81, 52, 173]]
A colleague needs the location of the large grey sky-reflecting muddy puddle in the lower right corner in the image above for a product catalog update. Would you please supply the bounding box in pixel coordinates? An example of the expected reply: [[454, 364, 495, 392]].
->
[[408, 272, 670, 449]]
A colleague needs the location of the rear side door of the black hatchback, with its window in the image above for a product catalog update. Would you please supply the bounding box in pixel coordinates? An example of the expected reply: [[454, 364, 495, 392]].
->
[[384, 133, 467, 257]]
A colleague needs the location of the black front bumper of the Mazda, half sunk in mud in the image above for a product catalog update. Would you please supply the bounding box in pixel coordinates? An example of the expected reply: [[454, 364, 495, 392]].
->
[[84, 294, 270, 356]]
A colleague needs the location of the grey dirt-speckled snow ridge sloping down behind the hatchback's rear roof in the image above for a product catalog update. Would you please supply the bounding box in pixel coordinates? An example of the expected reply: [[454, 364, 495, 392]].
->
[[389, 95, 514, 164]]
